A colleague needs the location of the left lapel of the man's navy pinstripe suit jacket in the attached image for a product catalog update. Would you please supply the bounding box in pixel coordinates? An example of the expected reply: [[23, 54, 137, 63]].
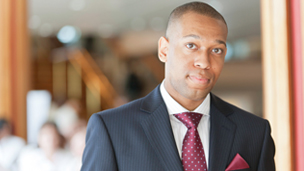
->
[[141, 86, 183, 171]]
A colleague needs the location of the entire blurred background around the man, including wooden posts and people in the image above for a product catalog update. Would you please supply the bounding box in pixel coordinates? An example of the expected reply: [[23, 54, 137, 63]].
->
[[0, 0, 304, 171]]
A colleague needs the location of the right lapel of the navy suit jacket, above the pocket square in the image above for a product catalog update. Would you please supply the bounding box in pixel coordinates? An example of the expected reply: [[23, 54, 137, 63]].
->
[[209, 95, 236, 170]]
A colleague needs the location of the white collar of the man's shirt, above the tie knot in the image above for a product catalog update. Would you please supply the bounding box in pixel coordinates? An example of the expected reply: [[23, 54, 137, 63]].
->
[[160, 80, 210, 115]]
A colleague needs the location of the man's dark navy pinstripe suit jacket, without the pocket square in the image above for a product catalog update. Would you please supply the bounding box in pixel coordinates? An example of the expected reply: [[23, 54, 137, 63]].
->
[[81, 86, 275, 171]]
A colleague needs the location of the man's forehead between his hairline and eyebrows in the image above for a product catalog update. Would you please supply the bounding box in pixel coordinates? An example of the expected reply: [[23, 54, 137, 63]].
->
[[168, 12, 228, 41]]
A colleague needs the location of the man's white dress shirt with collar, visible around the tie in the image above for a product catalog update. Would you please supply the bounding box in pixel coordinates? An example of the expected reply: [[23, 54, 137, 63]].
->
[[160, 81, 210, 167]]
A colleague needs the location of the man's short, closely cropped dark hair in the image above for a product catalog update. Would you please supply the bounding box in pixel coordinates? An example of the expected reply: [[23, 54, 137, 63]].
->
[[166, 2, 227, 37]]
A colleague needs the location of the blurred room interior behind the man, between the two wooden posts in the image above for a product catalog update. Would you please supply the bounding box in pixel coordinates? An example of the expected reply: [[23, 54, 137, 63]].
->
[[28, 0, 262, 119]]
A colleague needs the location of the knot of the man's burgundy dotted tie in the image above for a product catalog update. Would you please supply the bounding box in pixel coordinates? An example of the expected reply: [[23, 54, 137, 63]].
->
[[174, 112, 203, 129]]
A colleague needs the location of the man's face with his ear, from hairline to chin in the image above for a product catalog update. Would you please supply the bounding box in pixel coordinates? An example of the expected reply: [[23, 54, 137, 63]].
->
[[159, 12, 227, 109]]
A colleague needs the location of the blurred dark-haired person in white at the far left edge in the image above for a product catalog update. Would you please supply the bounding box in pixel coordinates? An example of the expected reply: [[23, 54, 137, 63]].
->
[[0, 119, 25, 171]]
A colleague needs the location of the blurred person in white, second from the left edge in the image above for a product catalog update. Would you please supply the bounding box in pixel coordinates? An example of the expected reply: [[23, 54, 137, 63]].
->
[[19, 122, 73, 171]]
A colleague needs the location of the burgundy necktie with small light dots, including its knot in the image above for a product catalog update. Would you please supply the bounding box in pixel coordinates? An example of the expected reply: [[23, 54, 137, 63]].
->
[[174, 112, 207, 171]]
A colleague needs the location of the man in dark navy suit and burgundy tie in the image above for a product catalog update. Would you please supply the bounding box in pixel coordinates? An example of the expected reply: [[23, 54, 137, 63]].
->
[[82, 2, 275, 171]]
